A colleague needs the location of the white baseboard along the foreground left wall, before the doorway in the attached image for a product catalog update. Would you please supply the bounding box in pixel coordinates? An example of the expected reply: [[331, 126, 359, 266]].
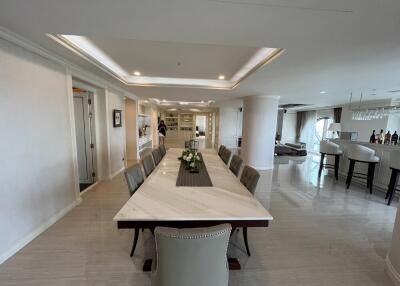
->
[[0, 198, 82, 264]]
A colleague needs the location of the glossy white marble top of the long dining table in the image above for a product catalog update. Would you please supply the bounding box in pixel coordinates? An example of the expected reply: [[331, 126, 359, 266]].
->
[[114, 149, 273, 221]]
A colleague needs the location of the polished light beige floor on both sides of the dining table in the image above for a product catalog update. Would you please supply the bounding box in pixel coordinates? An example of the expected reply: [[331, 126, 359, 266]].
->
[[0, 153, 397, 286]]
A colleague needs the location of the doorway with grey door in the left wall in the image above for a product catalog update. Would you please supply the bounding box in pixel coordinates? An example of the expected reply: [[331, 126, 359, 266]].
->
[[73, 87, 96, 192]]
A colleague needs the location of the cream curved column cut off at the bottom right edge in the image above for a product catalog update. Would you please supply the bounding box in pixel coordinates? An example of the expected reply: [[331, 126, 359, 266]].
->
[[385, 204, 400, 285]]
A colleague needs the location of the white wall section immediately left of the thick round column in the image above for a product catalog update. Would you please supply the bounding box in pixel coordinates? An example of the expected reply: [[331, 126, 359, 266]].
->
[[219, 100, 243, 148]]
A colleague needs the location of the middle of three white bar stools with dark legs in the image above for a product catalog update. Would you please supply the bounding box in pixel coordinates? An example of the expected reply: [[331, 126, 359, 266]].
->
[[346, 144, 379, 194]]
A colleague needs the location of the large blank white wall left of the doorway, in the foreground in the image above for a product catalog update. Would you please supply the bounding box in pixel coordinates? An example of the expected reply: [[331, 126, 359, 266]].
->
[[0, 39, 77, 263]]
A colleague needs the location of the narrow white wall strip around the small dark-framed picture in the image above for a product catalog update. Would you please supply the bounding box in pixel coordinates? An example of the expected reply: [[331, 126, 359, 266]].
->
[[107, 89, 126, 177]]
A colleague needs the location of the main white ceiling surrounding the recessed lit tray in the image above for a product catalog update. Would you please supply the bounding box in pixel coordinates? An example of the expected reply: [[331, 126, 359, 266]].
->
[[0, 0, 400, 106]]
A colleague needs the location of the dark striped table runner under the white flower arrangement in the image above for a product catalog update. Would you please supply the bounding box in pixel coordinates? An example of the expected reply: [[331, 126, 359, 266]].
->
[[176, 153, 213, 187]]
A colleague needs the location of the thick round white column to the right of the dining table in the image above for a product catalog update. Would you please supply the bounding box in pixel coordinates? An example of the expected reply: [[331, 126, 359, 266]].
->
[[242, 96, 279, 170]]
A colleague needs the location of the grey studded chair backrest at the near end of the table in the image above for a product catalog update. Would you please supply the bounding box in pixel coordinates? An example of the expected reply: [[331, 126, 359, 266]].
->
[[151, 224, 232, 286]]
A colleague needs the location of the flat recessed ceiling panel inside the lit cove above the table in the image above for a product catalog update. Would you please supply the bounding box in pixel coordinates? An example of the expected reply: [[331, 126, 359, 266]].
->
[[89, 37, 258, 79]]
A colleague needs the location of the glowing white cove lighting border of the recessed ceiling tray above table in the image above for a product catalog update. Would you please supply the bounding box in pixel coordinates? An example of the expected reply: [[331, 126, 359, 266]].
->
[[47, 34, 284, 90]]
